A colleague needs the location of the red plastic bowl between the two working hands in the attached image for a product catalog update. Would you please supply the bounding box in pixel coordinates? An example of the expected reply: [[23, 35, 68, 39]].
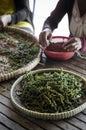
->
[[44, 36, 74, 60]]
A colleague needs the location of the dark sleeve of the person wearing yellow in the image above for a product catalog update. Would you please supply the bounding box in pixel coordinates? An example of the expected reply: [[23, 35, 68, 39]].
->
[[11, 0, 32, 24]]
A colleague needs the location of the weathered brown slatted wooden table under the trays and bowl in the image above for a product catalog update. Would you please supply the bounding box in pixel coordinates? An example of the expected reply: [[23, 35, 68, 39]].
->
[[0, 53, 86, 130]]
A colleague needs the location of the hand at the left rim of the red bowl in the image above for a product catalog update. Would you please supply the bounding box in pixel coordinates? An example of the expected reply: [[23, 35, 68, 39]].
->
[[39, 28, 52, 47]]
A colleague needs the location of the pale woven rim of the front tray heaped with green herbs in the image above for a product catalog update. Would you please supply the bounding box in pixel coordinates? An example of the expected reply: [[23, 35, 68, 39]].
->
[[10, 68, 86, 120]]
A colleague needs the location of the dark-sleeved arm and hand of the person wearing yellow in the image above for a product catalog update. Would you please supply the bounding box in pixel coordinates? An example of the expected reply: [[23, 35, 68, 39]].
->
[[0, 0, 32, 27]]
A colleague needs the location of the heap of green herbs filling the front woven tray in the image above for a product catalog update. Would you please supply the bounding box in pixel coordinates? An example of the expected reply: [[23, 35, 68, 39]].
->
[[19, 70, 85, 113]]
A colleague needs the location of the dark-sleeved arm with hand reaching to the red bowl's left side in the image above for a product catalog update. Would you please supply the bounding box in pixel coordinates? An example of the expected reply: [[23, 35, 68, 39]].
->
[[39, 0, 67, 46]]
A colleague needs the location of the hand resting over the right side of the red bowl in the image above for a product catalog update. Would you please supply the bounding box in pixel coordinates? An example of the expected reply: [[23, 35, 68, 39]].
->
[[63, 37, 82, 52]]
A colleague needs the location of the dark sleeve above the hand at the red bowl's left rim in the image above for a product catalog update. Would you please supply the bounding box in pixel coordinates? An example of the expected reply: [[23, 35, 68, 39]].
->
[[43, 0, 67, 31]]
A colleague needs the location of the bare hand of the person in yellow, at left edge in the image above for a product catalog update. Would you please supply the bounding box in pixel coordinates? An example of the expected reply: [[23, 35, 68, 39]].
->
[[0, 14, 11, 28]]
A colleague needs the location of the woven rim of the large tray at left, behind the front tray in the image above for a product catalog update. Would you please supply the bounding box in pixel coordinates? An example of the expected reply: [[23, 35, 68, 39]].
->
[[0, 27, 40, 81]]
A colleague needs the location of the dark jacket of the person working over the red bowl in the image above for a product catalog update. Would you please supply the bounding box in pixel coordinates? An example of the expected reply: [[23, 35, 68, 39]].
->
[[43, 0, 86, 51]]
